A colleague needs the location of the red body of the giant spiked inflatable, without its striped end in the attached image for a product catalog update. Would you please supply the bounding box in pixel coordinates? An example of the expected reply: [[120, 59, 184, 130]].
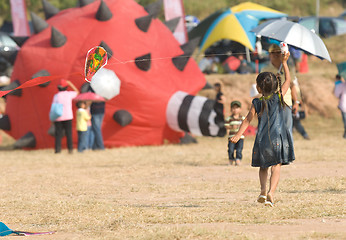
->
[[6, 0, 206, 148]]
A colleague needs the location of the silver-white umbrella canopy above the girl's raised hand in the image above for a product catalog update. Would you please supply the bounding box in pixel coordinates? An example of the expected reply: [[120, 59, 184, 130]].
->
[[252, 20, 332, 62]]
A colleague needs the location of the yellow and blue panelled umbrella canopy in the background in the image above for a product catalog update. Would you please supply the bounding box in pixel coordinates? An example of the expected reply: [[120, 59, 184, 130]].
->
[[189, 2, 286, 51]]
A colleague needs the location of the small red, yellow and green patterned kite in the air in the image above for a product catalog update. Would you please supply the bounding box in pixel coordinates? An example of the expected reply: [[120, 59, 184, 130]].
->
[[84, 46, 107, 82]]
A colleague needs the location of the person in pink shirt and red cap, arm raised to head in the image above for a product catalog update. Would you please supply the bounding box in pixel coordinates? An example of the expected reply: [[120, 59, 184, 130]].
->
[[53, 79, 79, 153]]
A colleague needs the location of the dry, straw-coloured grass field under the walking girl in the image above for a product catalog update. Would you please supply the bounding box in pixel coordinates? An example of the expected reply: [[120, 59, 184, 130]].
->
[[0, 113, 346, 240]]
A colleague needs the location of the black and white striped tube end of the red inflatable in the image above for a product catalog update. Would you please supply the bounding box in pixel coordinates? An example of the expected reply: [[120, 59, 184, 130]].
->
[[166, 91, 226, 137]]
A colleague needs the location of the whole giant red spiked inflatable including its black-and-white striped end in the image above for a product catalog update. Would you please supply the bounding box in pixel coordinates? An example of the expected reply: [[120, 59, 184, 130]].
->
[[0, 0, 224, 148]]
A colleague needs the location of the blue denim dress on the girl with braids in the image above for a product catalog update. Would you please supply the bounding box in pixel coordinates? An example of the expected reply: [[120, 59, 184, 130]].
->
[[251, 94, 295, 168]]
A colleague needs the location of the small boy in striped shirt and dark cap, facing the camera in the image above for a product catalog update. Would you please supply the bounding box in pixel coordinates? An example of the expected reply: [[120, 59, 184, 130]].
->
[[225, 101, 245, 166]]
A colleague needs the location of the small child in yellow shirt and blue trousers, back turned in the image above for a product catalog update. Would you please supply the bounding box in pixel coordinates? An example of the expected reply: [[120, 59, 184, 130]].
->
[[76, 101, 91, 152]]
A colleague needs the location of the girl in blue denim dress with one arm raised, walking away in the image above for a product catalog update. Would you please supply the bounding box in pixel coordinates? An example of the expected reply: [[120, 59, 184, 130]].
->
[[231, 53, 295, 207]]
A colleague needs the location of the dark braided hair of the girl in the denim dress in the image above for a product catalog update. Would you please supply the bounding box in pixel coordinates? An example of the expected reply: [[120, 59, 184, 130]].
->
[[256, 72, 285, 115]]
